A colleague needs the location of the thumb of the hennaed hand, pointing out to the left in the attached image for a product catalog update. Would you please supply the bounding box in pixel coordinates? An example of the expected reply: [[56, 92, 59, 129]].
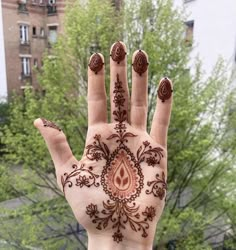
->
[[34, 118, 74, 169]]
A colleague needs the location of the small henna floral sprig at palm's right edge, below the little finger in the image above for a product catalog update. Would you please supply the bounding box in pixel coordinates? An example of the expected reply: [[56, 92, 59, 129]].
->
[[146, 172, 167, 200]]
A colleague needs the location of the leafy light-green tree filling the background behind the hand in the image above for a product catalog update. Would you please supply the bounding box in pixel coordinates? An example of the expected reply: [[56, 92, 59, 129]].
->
[[0, 0, 236, 250]]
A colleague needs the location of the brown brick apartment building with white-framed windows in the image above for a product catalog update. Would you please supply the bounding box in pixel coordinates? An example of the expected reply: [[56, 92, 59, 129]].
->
[[0, 0, 65, 95]]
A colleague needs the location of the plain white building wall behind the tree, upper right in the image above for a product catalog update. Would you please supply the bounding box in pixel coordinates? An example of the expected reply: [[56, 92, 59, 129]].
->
[[174, 0, 236, 75]]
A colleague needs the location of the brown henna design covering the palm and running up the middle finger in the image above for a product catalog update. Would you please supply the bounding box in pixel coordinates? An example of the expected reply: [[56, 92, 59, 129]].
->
[[61, 74, 166, 243]]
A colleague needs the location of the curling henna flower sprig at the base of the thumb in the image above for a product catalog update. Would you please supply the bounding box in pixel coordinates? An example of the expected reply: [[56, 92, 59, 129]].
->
[[61, 164, 100, 193]]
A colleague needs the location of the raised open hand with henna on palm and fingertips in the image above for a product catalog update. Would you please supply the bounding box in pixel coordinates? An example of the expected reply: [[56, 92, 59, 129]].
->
[[35, 42, 172, 250]]
